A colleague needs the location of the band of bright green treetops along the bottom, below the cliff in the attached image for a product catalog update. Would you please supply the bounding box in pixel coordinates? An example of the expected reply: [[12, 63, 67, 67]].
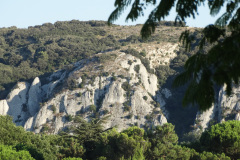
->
[[0, 116, 240, 160]]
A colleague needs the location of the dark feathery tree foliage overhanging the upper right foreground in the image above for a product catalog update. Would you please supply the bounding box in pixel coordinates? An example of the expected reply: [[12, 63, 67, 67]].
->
[[108, 0, 240, 110]]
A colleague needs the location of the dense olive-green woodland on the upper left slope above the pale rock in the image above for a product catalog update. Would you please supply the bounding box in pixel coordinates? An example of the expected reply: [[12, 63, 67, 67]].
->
[[0, 20, 120, 98]]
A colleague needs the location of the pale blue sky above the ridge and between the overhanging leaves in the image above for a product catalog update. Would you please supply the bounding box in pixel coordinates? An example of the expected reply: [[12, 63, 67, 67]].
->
[[0, 0, 225, 28]]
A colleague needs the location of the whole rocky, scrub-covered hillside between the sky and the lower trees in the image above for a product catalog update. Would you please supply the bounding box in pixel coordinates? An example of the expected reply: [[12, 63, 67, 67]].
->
[[0, 21, 239, 139]]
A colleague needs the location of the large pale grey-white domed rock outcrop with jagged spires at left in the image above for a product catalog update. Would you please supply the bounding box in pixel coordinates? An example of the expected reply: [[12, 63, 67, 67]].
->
[[0, 51, 171, 134]]
